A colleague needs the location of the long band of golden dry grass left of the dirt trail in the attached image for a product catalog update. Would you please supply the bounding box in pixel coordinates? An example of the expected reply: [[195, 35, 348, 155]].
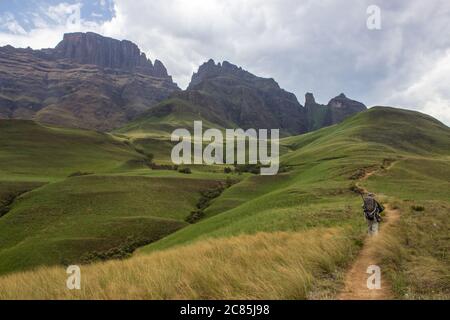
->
[[0, 228, 357, 299]]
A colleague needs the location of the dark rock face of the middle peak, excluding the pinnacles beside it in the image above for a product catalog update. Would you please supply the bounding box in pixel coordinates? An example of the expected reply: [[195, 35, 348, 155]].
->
[[180, 60, 307, 135]]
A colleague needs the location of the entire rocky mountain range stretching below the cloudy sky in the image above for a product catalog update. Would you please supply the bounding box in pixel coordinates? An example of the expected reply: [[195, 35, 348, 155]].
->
[[0, 32, 366, 136]]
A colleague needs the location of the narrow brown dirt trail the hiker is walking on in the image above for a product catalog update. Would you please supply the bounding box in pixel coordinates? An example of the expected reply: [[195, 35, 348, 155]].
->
[[337, 166, 400, 300]]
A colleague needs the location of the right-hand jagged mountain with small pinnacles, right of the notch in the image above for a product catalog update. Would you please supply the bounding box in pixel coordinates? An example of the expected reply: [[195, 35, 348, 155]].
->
[[121, 59, 367, 136]]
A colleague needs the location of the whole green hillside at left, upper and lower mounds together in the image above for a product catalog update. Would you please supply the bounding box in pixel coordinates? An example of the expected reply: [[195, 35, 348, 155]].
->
[[0, 120, 223, 273]]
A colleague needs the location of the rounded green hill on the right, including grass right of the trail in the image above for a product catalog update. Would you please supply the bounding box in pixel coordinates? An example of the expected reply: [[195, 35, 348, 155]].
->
[[131, 108, 450, 298]]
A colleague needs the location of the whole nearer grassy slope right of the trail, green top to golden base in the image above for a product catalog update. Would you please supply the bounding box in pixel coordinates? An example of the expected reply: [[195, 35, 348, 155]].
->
[[367, 156, 450, 299]]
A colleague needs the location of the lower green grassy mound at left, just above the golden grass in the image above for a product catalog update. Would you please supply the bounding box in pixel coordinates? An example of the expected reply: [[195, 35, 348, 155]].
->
[[0, 176, 220, 272]]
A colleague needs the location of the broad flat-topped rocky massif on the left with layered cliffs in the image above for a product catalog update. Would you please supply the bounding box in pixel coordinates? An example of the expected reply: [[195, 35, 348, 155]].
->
[[0, 33, 179, 130]]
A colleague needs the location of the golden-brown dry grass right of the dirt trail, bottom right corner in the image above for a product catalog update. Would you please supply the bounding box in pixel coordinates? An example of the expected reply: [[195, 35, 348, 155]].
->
[[374, 201, 450, 300]]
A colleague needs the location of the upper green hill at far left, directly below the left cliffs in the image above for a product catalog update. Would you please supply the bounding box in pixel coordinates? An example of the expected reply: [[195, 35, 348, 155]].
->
[[0, 120, 144, 181]]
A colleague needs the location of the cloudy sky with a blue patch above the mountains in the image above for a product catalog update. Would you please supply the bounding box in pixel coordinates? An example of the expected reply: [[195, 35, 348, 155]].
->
[[0, 0, 450, 125]]
